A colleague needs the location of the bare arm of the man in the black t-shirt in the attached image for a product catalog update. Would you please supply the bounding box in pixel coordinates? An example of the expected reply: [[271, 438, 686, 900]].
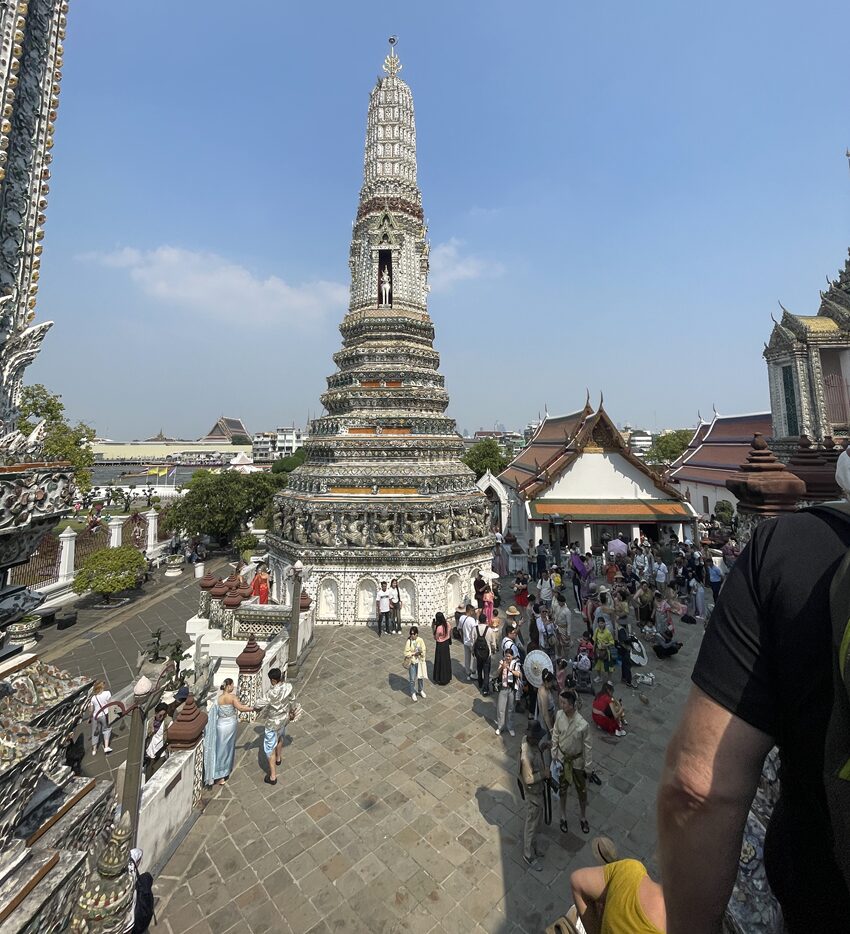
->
[[658, 686, 774, 934]]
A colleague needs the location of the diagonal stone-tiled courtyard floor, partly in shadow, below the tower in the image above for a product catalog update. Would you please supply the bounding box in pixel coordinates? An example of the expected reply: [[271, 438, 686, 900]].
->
[[155, 625, 702, 934]]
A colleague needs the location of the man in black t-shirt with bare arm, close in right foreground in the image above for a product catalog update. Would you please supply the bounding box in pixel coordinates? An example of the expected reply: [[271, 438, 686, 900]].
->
[[658, 512, 850, 934]]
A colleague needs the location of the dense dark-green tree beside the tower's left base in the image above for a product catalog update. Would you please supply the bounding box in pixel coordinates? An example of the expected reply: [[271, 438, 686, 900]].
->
[[162, 470, 286, 543]]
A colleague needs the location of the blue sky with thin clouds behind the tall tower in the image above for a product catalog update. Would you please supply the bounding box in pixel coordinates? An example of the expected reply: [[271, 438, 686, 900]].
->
[[26, 0, 850, 438]]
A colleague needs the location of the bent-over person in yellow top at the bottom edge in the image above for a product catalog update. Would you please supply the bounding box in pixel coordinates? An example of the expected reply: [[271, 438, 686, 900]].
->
[[570, 859, 667, 934]]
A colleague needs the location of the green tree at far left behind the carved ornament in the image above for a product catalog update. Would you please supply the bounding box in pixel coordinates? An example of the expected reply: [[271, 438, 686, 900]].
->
[[18, 383, 94, 493]]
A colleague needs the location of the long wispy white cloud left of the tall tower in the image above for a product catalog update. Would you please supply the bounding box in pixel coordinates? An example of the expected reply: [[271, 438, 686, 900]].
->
[[83, 246, 348, 326]]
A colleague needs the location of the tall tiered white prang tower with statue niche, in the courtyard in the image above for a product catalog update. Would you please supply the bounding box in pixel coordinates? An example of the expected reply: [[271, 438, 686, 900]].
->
[[268, 38, 493, 624]]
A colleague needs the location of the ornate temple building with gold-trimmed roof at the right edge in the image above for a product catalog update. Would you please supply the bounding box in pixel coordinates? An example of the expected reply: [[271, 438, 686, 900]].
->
[[764, 249, 850, 460]]
